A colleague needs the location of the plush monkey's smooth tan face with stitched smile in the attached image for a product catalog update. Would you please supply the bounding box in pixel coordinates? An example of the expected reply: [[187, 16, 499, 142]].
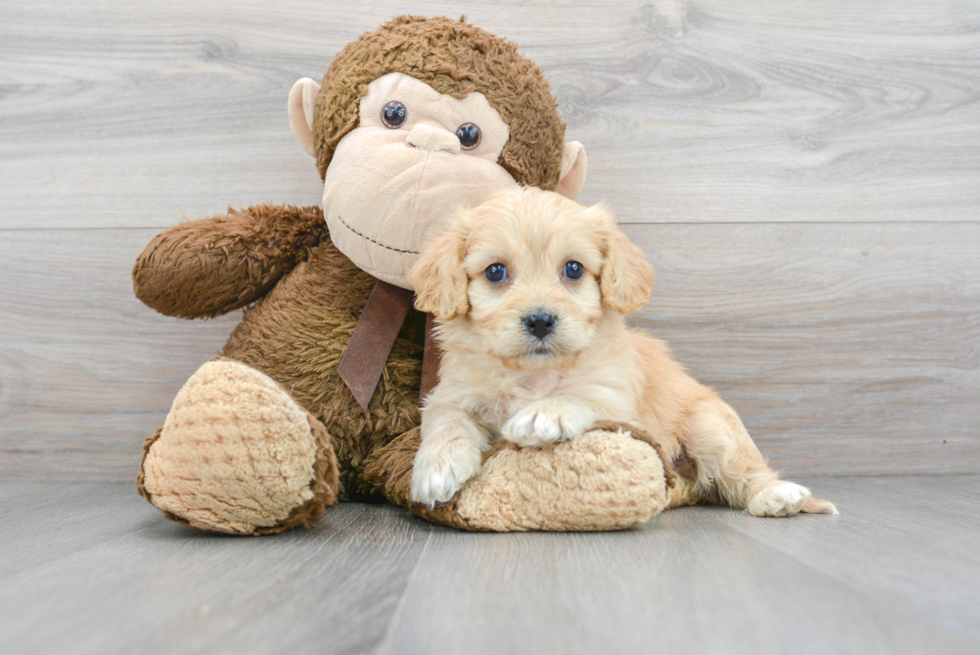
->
[[323, 73, 517, 289]]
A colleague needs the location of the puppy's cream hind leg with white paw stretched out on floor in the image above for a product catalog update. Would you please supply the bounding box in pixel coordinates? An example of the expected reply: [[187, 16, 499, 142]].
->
[[682, 398, 837, 516]]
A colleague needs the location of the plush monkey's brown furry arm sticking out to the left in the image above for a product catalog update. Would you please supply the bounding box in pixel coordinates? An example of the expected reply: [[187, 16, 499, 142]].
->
[[133, 205, 327, 318]]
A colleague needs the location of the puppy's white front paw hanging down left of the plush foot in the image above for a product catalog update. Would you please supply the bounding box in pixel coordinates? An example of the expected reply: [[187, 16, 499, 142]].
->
[[409, 439, 482, 507]]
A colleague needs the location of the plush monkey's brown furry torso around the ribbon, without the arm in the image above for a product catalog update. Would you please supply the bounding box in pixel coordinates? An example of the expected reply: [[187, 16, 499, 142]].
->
[[222, 215, 425, 497]]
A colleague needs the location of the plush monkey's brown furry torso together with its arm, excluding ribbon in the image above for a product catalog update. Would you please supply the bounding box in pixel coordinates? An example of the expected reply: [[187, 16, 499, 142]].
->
[[133, 205, 425, 497]]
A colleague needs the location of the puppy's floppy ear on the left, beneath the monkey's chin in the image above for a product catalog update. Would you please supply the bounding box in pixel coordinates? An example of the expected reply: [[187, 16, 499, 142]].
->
[[408, 215, 470, 321]]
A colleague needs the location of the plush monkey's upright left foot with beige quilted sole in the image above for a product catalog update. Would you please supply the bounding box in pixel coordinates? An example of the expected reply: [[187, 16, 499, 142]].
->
[[138, 359, 339, 534]]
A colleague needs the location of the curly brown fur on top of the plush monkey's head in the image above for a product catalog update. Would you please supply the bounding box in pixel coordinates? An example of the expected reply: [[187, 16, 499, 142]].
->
[[313, 16, 565, 191]]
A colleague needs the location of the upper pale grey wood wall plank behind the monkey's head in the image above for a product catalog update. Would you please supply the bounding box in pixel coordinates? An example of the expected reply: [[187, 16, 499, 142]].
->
[[0, 0, 980, 228]]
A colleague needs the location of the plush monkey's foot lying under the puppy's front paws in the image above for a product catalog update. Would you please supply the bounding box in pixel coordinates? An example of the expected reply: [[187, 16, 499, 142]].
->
[[366, 428, 671, 532]]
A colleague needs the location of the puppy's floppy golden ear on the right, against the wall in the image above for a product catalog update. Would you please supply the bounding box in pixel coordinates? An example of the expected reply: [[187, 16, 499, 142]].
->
[[593, 207, 655, 314]]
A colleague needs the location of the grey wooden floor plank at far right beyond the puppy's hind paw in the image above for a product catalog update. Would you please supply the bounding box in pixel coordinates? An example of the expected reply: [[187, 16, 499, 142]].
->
[[724, 476, 980, 650]]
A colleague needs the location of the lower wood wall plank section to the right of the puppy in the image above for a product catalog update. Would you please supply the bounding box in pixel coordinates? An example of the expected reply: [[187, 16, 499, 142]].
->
[[628, 224, 980, 476]]
